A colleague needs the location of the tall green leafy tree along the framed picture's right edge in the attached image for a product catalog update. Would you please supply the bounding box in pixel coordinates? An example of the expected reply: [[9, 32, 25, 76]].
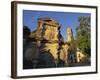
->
[[76, 16, 91, 55]]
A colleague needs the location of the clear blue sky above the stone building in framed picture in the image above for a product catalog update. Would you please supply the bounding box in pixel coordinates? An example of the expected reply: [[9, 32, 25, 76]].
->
[[23, 10, 91, 40]]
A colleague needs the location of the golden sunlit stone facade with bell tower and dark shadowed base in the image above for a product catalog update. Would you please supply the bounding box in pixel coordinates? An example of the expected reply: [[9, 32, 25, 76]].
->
[[24, 18, 88, 68]]
